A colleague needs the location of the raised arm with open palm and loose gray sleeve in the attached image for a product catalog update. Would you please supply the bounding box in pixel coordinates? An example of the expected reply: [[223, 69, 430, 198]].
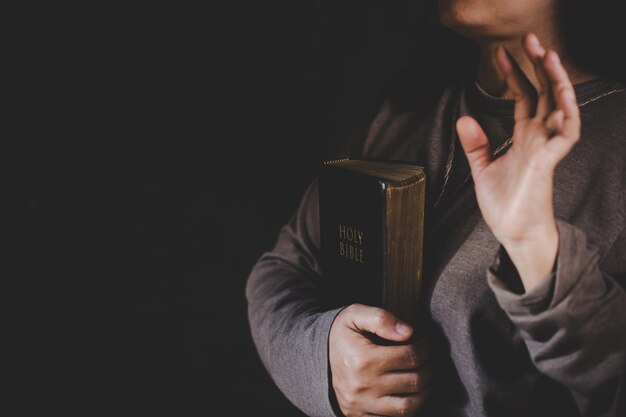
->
[[457, 36, 626, 415]]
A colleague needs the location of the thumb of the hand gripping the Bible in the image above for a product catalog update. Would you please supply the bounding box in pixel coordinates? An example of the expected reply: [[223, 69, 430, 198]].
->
[[350, 304, 413, 342]]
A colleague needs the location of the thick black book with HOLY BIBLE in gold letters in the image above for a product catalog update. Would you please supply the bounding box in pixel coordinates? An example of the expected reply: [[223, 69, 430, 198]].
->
[[319, 159, 426, 326]]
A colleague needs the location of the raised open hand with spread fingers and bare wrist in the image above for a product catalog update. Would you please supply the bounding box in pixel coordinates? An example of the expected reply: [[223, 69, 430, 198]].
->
[[457, 34, 580, 290]]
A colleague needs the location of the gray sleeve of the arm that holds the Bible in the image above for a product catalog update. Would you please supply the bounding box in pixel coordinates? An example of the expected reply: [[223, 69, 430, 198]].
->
[[246, 182, 340, 416]]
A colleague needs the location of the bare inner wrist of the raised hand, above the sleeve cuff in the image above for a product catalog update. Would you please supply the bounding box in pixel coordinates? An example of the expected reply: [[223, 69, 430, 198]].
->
[[501, 222, 559, 292]]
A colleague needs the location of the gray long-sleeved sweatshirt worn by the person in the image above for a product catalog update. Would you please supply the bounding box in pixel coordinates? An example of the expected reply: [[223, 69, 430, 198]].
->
[[246, 70, 626, 417]]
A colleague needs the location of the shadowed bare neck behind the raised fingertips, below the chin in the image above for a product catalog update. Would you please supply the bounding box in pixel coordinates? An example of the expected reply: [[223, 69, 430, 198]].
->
[[477, 35, 595, 99]]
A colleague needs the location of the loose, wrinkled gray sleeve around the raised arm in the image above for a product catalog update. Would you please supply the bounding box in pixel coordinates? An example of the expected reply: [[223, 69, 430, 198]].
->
[[487, 221, 626, 416]]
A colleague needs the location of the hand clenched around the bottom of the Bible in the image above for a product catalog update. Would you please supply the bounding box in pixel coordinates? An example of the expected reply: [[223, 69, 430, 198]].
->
[[328, 304, 431, 417]]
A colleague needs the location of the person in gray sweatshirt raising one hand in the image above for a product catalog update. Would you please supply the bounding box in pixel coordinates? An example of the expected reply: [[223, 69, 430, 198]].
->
[[246, 0, 626, 416]]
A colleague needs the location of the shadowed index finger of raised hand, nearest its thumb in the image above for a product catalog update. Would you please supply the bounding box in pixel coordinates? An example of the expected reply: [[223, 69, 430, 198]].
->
[[496, 46, 537, 121]]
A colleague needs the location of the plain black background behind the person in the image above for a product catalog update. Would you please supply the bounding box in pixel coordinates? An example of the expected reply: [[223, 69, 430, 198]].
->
[[11, 0, 626, 416]]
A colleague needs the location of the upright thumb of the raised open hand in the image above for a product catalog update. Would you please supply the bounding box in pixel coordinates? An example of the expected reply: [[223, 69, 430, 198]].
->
[[456, 116, 492, 178]]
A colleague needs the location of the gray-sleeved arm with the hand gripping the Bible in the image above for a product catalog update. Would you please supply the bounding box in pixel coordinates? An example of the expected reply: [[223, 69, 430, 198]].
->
[[246, 183, 431, 417]]
